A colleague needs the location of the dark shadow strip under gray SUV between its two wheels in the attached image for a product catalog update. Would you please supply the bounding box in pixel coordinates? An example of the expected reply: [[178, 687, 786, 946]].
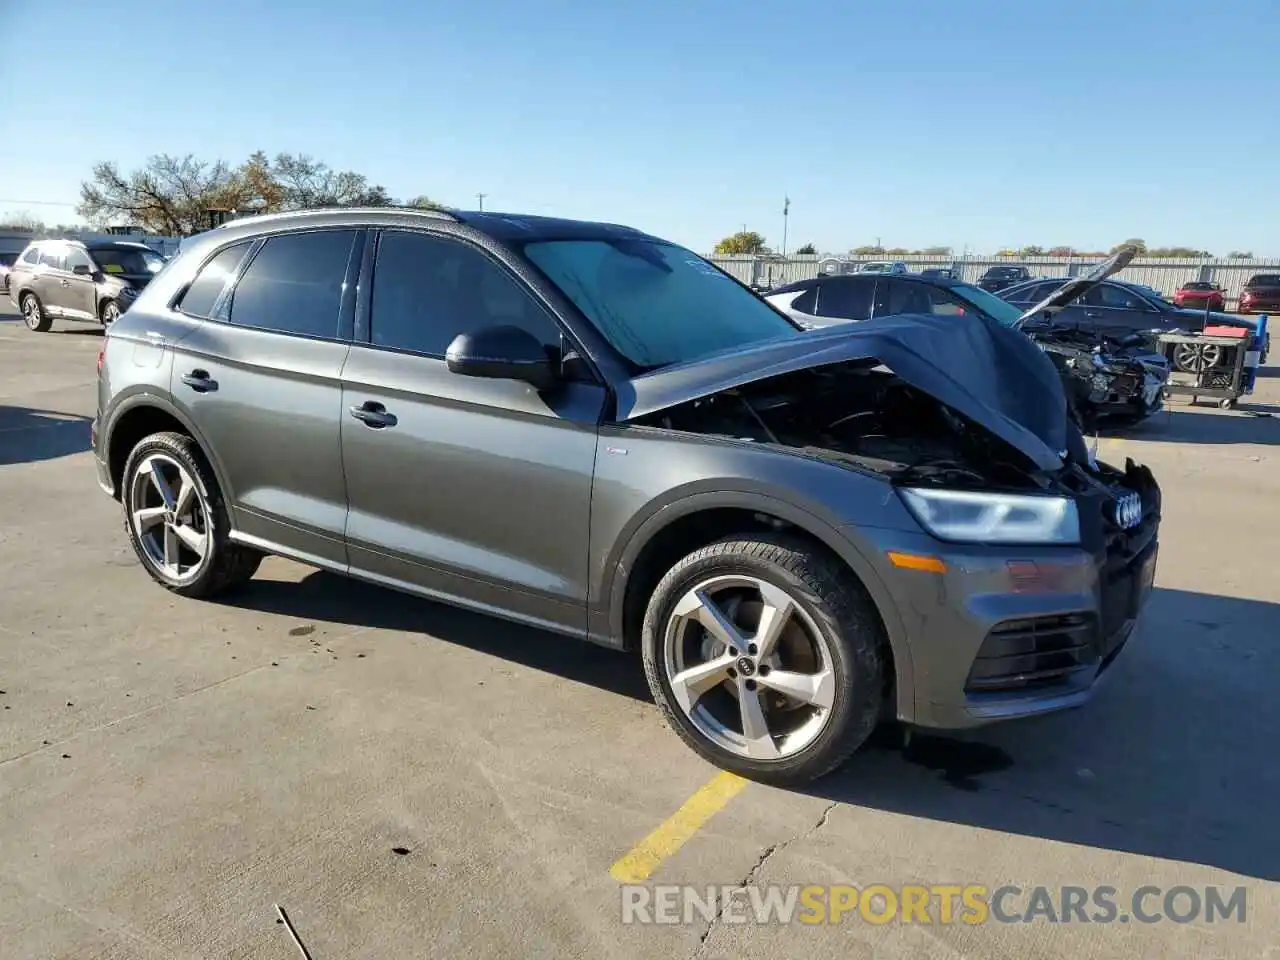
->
[[220, 571, 653, 701]]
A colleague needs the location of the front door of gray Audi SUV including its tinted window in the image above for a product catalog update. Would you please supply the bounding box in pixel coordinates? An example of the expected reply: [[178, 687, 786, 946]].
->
[[342, 230, 604, 634]]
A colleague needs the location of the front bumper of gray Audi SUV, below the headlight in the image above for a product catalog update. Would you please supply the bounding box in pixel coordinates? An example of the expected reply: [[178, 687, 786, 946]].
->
[[878, 465, 1160, 728]]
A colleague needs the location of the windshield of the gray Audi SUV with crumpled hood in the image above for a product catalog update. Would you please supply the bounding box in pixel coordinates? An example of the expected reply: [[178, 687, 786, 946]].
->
[[525, 239, 803, 369]]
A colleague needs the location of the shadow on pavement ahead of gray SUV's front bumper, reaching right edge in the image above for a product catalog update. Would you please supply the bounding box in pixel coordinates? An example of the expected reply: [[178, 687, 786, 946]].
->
[[806, 589, 1280, 881]]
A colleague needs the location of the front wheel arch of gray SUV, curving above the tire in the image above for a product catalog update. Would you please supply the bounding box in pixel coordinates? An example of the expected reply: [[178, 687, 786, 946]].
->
[[607, 494, 914, 712]]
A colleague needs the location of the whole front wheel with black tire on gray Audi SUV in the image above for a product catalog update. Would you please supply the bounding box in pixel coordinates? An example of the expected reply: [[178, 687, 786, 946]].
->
[[641, 534, 886, 786]]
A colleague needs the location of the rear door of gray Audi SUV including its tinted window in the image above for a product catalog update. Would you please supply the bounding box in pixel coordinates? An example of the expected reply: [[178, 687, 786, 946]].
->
[[172, 228, 364, 568]]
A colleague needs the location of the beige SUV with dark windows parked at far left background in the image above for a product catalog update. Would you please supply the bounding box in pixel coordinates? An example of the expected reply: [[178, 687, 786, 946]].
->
[[8, 239, 166, 333]]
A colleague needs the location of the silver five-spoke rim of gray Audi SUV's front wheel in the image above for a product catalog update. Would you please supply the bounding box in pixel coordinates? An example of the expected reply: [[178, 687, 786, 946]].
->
[[663, 575, 836, 760]]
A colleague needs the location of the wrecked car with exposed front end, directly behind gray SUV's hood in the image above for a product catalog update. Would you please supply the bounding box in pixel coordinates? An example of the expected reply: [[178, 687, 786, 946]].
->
[[765, 256, 1169, 429]]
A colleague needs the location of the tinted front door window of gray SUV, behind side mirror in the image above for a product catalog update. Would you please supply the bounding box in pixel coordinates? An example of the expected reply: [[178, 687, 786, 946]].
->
[[369, 230, 561, 356]]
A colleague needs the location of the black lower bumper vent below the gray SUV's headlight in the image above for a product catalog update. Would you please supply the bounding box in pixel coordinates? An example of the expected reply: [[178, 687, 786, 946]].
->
[[965, 613, 1101, 694]]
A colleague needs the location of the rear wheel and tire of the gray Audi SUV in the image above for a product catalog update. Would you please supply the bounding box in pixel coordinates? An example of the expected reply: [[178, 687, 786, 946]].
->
[[120, 433, 262, 598]]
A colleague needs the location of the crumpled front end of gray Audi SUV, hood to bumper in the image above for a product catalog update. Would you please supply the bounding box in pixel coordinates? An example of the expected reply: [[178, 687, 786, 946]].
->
[[619, 305, 1161, 728]]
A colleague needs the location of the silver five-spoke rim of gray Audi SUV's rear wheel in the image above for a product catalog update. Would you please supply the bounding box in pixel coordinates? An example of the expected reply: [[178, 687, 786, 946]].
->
[[129, 453, 212, 582]]
